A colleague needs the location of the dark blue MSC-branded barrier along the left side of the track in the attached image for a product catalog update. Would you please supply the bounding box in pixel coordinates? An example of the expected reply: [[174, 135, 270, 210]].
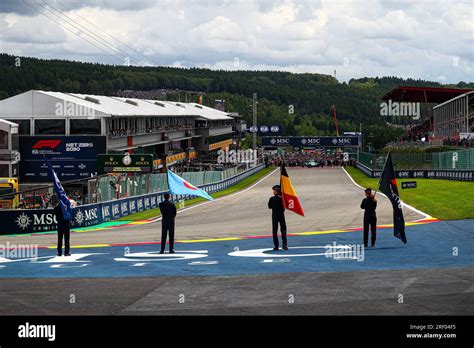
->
[[0, 164, 265, 235]]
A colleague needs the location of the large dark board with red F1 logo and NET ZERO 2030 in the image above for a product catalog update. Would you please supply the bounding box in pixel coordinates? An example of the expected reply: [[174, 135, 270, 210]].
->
[[20, 136, 106, 183]]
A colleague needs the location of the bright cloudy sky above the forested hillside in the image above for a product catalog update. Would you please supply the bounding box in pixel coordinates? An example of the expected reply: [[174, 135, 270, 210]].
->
[[0, 0, 474, 83]]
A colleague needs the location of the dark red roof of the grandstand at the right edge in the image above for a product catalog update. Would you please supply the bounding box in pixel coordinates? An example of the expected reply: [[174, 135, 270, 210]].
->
[[382, 86, 472, 104]]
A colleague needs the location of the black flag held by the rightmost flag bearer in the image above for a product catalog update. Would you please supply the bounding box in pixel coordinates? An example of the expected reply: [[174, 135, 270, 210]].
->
[[379, 153, 407, 244]]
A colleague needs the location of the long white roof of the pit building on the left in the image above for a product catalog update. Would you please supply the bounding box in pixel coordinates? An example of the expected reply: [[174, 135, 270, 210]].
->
[[0, 90, 232, 120]]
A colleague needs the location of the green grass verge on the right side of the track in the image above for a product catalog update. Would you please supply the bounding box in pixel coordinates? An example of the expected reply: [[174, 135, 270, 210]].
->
[[346, 167, 474, 220]]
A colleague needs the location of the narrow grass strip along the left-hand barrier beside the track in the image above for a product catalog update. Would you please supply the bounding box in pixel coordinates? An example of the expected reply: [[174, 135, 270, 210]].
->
[[116, 167, 275, 221]]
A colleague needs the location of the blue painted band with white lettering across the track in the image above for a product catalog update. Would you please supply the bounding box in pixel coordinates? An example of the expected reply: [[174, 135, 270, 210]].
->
[[0, 220, 474, 278]]
